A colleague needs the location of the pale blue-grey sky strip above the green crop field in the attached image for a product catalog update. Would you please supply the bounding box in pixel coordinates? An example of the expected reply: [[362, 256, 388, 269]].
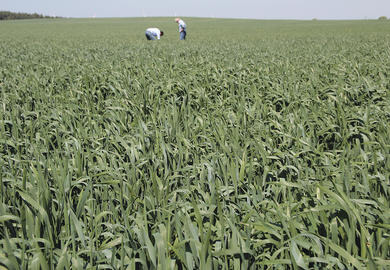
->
[[0, 0, 390, 20]]
